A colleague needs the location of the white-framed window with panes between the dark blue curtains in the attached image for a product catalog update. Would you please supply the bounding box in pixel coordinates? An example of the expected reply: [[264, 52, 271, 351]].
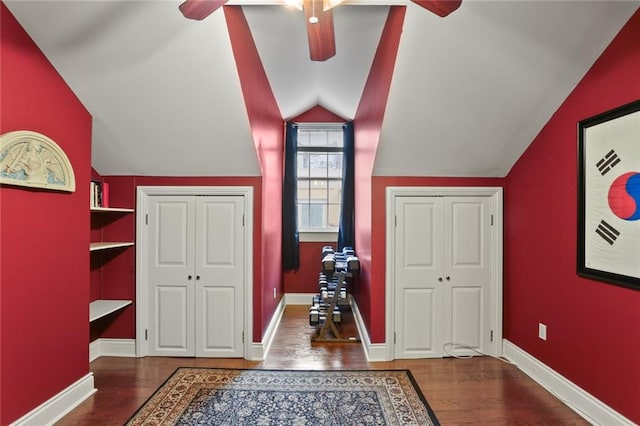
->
[[296, 123, 344, 232]]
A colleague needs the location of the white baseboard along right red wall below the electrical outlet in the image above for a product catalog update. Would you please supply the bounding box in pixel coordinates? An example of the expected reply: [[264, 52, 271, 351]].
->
[[502, 339, 635, 426]]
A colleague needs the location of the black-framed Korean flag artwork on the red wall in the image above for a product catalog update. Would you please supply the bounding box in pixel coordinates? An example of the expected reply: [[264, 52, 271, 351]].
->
[[578, 100, 640, 290]]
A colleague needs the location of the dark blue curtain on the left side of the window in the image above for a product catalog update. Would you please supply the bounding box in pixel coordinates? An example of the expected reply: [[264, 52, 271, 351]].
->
[[282, 122, 300, 271]]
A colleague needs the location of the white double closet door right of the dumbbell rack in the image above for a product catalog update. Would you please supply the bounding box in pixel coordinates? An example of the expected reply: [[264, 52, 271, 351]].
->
[[394, 196, 492, 358]]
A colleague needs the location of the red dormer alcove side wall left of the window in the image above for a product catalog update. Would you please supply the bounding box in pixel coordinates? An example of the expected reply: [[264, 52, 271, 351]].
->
[[224, 6, 284, 342]]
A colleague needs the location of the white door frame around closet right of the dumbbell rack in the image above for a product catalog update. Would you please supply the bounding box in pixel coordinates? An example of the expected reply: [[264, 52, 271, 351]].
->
[[385, 186, 503, 361]]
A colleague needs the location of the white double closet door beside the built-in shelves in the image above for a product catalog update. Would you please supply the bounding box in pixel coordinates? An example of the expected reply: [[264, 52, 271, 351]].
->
[[147, 195, 245, 357]]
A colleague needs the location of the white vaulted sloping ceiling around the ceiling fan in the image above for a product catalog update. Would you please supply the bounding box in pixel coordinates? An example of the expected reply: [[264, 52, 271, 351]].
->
[[3, 0, 640, 176]]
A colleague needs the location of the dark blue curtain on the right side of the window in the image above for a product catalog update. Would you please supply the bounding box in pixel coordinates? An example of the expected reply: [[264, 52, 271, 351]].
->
[[338, 121, 356, 250]]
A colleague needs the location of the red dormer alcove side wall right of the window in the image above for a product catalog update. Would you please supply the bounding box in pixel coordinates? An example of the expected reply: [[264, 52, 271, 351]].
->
[[353, 6, 406, 343]]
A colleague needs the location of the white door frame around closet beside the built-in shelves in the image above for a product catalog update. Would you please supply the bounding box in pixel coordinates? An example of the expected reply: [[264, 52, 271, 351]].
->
[[136, 186, 253, 359]]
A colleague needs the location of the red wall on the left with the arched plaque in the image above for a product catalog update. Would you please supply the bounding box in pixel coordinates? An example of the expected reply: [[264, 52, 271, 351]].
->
[[0, 3, 91, 424]]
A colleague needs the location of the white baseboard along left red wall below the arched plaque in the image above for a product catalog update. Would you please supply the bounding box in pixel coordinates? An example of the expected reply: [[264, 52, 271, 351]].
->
[[11, 373, 96, 426]]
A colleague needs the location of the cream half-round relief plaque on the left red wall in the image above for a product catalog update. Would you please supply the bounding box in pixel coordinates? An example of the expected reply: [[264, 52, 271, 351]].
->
[[0, 130, 76, 192]]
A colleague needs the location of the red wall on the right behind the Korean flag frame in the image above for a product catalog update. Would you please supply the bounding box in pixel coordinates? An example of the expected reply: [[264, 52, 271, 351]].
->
[[504, 11, 640, 423]]
